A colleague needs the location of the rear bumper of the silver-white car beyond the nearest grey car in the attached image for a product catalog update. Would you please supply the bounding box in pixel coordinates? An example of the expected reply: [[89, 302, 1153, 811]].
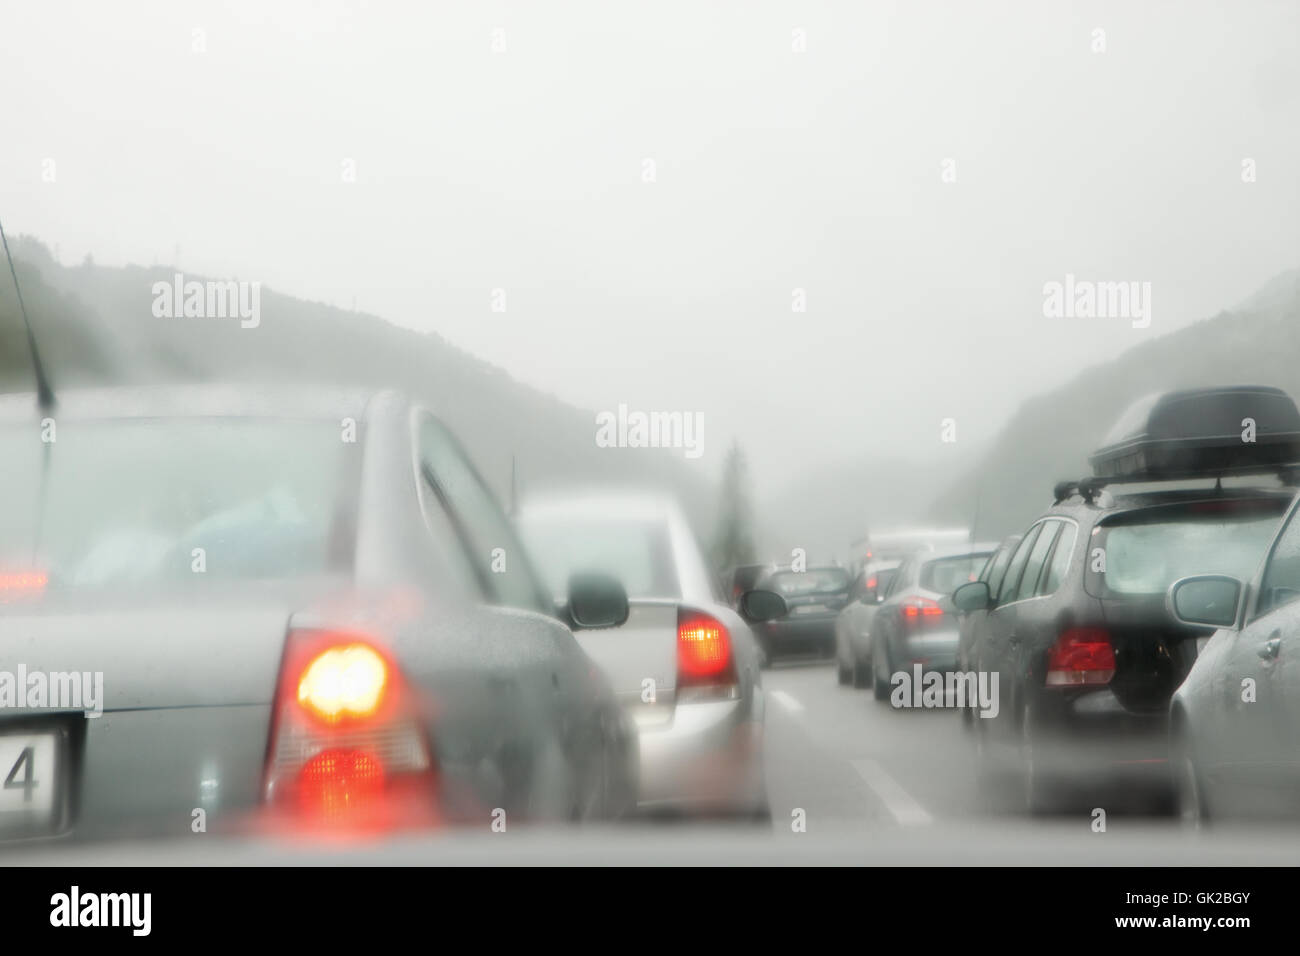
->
[[637, 700, 763, 809]]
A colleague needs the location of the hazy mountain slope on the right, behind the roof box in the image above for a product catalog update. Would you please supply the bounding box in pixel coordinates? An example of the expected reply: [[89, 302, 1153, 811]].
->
[[931, 269, 1300, 537]]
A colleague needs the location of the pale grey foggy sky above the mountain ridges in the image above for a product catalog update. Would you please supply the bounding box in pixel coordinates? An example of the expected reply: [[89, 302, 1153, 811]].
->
[[0, 0, 1300, 502]]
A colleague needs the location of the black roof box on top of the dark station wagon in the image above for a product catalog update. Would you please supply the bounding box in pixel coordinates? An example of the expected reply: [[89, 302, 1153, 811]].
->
[[1088, 385, 1300, 481]]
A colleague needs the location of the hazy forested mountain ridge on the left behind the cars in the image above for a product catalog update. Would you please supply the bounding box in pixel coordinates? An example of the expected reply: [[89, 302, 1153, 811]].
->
[[0, 237, 714, 522]]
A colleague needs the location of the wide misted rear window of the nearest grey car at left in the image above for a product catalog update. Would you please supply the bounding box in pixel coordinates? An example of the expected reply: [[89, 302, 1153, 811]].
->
[[0, 419, 358, 589]]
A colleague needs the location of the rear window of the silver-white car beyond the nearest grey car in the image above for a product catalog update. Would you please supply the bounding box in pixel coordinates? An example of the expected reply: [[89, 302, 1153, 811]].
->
[[519, 514, 681, 600]]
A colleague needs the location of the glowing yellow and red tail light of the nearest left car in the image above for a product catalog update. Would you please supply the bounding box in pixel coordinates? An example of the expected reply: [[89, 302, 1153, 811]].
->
[[265, 630, 437, 827]]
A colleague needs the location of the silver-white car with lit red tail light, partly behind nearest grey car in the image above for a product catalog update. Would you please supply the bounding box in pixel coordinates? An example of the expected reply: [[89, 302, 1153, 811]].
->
[[519, 492, 767, 818]]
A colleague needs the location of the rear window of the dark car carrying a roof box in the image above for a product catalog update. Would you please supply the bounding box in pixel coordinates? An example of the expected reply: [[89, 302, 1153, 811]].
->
[[1086, 498, 1287, 597]]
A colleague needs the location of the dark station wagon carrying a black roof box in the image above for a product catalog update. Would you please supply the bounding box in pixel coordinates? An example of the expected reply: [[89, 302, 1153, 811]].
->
[[953, 389, 1297, 810]]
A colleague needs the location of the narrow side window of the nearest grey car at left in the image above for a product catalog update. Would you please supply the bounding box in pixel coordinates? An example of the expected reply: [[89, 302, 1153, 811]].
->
[[420, 418, 549, 611]]
